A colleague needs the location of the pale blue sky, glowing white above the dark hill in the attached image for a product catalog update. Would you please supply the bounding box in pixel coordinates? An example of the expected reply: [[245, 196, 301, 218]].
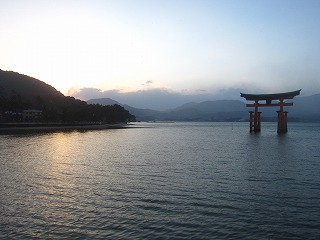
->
[[0, 0, 320, 97]]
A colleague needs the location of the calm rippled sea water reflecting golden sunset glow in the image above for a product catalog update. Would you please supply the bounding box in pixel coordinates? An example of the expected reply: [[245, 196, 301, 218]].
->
[[0, 123, 320, 239]]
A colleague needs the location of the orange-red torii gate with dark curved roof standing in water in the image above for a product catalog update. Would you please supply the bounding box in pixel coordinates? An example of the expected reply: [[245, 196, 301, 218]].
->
[[240, 89, 301, 133]]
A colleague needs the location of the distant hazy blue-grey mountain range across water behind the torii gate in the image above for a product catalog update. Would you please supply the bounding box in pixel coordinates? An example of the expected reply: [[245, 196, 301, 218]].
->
[[89, 94, 320, 121]]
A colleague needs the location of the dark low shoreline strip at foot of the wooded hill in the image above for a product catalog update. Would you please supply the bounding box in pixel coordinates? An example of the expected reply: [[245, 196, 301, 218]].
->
[[0, 123, 128, 134]]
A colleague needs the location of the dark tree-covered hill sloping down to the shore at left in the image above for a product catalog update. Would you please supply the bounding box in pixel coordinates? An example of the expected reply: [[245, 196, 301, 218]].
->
[[0, 70, 134, 123]]
